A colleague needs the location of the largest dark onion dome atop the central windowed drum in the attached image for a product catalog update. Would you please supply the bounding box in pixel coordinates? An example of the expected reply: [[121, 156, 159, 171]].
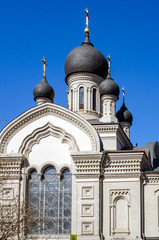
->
[[65, 34, 108, 78]]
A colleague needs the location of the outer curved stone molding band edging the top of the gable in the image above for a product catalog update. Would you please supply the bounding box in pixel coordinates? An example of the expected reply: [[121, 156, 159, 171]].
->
[[0, 103, 100, 153]]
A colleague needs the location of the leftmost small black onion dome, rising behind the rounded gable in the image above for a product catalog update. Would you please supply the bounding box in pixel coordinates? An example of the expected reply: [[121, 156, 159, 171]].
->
[[33, 77, 55, 101]]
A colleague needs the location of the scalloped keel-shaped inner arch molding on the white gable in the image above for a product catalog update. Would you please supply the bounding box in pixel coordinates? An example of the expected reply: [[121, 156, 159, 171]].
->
[[19, 122, 79, 156]]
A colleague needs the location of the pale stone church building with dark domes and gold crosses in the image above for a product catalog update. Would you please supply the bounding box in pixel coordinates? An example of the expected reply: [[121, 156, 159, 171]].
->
[[0, 10, 159, 240]]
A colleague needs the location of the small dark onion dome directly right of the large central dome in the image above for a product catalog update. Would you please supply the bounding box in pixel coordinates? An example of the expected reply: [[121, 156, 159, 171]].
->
[[99, 73, 119, 98]]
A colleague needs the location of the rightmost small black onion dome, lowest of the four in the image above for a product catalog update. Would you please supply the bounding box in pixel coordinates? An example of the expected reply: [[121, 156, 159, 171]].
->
[[116, 103, 133, 125]]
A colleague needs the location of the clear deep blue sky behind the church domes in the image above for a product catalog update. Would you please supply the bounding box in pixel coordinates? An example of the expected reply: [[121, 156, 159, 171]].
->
[[0, 0, 159, 146]]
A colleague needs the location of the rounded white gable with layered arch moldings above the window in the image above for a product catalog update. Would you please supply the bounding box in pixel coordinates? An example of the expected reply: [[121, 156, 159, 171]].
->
[[1, 103, 100, 154]]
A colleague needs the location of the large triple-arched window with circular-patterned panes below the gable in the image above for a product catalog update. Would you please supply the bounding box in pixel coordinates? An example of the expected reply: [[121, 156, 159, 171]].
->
[[28, 166, 72, 235]]
